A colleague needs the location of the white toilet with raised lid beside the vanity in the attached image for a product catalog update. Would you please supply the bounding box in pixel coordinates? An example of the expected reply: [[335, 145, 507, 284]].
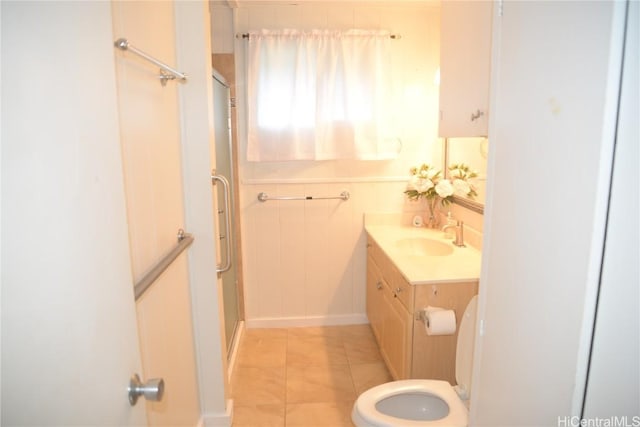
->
[[351, 295, 478, 427]]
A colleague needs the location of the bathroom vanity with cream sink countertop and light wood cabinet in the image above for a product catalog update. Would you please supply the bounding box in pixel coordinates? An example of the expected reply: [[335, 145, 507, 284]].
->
[[365, 216, 480, 384]]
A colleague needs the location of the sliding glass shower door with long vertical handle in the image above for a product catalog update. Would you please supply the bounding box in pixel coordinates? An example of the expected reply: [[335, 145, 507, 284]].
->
[[213, 72, 240, 355]]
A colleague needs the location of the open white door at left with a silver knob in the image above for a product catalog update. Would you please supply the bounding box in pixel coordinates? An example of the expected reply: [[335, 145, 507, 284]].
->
[[0, 2, 147, 426]]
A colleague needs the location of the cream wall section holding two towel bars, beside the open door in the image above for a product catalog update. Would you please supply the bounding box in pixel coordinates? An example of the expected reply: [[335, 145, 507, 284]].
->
[[111, 1, 200, 426]]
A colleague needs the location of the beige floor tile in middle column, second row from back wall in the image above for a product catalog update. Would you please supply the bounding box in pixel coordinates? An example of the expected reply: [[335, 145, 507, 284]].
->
[[287, 336, 349, 366]]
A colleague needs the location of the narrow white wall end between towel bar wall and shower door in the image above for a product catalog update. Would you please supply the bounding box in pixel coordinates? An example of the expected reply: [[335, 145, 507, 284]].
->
[[174, 1, 233, 426]]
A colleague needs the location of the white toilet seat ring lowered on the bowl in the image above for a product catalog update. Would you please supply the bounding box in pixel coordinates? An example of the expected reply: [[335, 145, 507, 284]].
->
[[352, 380, 468, 427]]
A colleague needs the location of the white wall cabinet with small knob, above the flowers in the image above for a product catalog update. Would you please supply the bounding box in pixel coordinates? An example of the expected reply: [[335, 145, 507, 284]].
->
[[438, 0, 492, 137]]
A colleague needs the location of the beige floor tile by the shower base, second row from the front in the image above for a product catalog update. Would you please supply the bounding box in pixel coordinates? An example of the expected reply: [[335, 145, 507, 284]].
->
[[231, 366, 286, 405]]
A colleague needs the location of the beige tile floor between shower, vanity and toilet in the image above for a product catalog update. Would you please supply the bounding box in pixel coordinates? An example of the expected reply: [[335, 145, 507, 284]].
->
[[231, 325, 391, 427]]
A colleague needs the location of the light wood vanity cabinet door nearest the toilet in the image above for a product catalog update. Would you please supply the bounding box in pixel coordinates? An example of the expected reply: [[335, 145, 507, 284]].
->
[[380, 286, 413, 380]]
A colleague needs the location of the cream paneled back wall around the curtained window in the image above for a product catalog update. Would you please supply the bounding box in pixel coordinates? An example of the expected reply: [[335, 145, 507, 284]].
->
[[213, 2, 450, 326]]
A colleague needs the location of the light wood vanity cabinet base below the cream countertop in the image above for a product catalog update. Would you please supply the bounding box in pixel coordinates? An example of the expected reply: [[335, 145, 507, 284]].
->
[[366, 238, 478, 384]]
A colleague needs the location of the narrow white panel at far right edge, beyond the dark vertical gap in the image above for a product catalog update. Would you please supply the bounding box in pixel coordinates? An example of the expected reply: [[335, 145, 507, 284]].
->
[[581, 1, 640, 414]]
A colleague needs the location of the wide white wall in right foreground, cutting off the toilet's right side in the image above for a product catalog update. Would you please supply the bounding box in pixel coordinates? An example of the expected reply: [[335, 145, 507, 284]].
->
[[470, 2, 624, 426]]
